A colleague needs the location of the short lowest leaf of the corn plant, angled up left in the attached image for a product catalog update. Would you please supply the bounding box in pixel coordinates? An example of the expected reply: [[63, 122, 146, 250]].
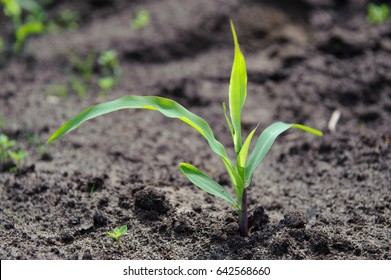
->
[[179, 163, 238, 209]]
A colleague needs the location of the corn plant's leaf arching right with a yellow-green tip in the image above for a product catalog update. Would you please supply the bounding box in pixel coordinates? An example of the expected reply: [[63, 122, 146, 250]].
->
[[245, 122, 323, 185]]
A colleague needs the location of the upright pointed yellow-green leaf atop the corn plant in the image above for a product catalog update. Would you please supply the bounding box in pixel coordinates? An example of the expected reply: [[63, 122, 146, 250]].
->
[[229, 21, 247, 154]]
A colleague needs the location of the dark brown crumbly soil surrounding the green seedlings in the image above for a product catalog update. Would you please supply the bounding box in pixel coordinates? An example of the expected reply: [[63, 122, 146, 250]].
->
[[0, 0, 391, 259]]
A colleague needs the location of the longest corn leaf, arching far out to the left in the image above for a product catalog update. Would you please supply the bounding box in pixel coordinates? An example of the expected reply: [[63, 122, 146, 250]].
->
[[47, 96, 233, 161]]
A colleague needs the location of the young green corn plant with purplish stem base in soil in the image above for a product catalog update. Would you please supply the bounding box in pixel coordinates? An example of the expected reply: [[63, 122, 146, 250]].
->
[[48, 22, 322, 236]]
